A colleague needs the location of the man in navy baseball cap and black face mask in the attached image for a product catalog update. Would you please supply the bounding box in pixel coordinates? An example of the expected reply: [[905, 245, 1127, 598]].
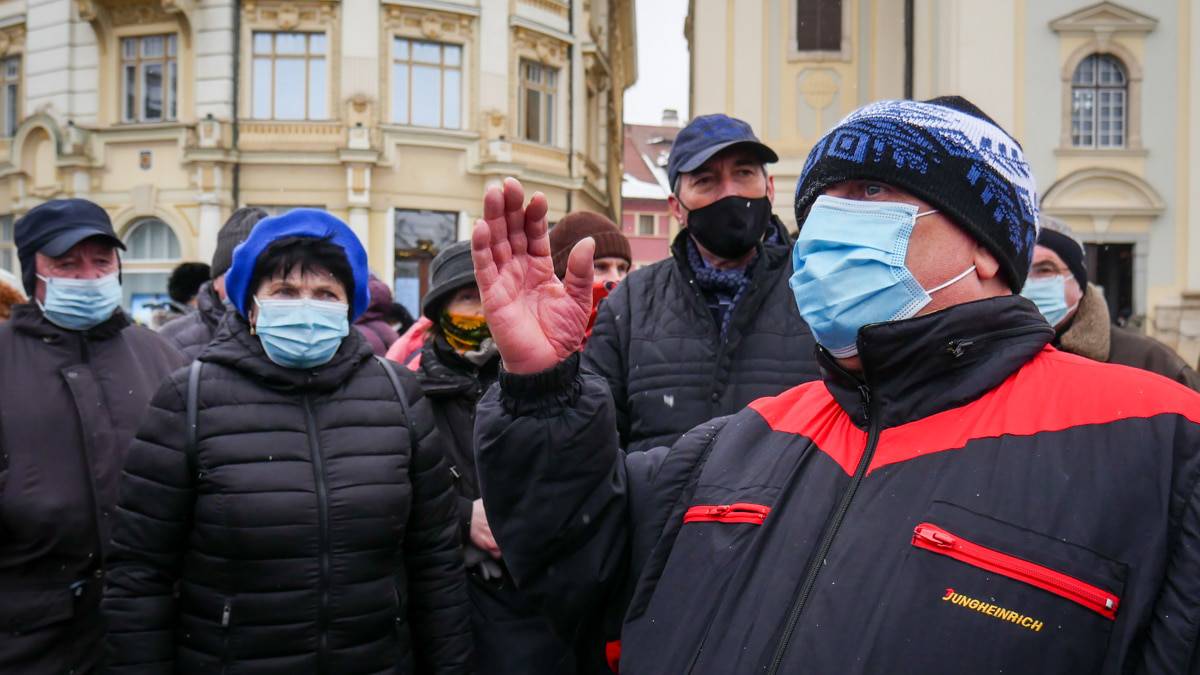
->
[[583, 114, 817, 450]]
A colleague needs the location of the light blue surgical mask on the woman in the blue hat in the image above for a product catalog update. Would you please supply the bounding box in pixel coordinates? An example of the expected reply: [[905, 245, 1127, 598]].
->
[[254, 298, 350, 369]]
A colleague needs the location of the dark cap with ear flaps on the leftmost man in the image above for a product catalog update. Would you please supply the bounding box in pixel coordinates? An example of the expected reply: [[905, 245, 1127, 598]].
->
[[13, 198, 125, 293]]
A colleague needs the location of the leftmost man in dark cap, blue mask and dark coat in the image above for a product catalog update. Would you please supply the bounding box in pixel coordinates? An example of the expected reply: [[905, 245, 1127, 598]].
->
[[0, 199, 185, 674]]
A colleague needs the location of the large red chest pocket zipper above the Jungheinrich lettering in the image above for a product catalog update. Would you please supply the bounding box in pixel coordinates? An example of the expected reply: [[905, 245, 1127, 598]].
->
[[912, 522, 1121, 620]]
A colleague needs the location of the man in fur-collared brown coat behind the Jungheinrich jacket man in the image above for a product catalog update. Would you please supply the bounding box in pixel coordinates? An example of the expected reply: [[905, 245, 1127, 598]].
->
[[1021, 216, 1200, 390]]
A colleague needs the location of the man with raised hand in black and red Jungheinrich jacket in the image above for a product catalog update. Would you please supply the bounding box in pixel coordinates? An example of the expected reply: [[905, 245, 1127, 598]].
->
[[473, 97, 1200, 675]]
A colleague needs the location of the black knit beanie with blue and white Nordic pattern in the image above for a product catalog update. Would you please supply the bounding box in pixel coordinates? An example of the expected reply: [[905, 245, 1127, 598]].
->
[[796, 96, 1038, 293]]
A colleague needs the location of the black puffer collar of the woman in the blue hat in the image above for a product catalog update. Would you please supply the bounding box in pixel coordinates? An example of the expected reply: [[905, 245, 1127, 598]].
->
[[198, 311, 374, 393]]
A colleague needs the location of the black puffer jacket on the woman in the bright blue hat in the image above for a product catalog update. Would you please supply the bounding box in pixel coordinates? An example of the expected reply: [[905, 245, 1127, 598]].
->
[[104, 312, 470, 675]]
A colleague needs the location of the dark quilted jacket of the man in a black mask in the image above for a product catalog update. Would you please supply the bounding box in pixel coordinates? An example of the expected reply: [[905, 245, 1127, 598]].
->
[[583, 222, 818, 450]]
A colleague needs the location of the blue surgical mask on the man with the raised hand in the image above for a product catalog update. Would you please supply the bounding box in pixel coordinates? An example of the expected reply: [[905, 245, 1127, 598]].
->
[[788, 196, 974, 358]]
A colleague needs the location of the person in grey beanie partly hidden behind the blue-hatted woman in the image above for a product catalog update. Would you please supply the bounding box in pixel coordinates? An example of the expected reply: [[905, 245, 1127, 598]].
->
[[158, 207, 266, 359]]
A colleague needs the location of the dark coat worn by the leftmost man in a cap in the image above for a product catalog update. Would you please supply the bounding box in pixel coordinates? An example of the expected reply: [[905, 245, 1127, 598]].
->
[[0, 304, 185, 675]]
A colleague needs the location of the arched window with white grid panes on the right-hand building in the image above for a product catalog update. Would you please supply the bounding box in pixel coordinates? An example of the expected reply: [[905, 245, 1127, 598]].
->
[[1070, 54, 1129, 148]]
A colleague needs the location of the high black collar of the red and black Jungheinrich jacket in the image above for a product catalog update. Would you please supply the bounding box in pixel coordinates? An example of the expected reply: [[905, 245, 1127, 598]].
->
[[817, 295, 1054, 429]]
